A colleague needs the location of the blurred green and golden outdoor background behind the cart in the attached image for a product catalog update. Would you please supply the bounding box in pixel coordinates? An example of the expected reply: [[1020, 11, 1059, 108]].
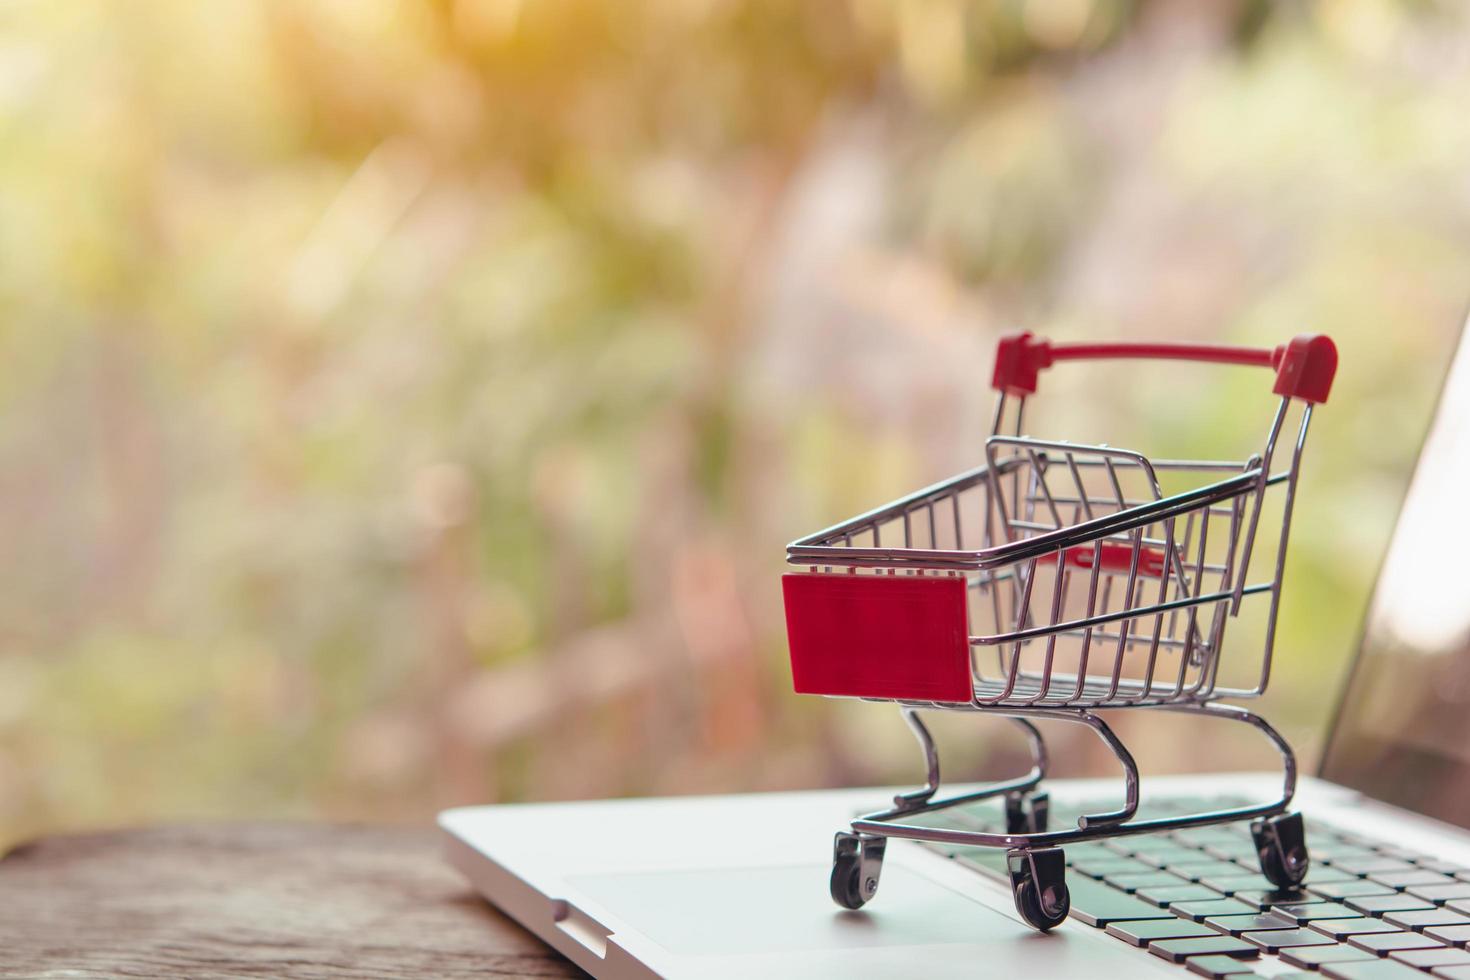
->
[[0, 0, 1470, 840]]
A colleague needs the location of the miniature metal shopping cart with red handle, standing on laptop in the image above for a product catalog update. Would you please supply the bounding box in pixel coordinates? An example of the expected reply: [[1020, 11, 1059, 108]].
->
[[782, 334, 1338, 930]]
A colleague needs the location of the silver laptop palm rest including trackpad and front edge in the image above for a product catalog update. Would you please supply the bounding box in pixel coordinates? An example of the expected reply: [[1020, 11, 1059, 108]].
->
[[440, 789, 1177, 980]]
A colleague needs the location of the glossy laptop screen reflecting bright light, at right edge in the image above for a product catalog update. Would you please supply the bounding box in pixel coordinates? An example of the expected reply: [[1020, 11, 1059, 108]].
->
[[1322, 318, 1470, 826]]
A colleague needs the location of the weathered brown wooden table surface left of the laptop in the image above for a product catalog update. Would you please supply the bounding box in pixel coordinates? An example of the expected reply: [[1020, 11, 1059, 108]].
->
[[0, 824, 581, 977]]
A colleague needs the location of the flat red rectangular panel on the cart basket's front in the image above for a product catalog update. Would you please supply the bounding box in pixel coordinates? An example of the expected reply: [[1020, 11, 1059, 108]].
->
[[782, 572, 975, 702]]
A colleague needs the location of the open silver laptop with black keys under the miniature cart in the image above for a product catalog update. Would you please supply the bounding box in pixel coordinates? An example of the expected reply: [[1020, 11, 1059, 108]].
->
[[440, 321, 1470, 980]]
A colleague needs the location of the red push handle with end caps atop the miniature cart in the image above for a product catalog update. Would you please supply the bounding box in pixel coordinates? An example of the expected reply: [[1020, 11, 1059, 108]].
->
[[991, 332, 1338, 404]]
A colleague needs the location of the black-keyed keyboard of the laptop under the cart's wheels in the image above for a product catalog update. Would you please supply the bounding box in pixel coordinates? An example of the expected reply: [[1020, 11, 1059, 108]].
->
[[925, 799, 1470, 980]]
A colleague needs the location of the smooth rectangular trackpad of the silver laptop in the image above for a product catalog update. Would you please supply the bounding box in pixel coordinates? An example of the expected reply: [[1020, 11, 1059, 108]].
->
[[569, 861, 1029, 955]]
